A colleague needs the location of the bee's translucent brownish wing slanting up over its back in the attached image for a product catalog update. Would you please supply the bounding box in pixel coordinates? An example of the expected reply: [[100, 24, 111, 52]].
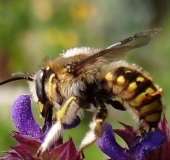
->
[[74, 28, 161, 70]]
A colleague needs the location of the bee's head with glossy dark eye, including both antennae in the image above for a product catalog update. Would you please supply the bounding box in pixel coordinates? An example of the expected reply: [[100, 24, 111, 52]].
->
[[0, 63, 54, 104]]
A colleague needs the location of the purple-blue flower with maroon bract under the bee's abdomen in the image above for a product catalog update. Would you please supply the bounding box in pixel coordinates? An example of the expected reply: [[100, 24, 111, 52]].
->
[[97, 118, 167, 160]]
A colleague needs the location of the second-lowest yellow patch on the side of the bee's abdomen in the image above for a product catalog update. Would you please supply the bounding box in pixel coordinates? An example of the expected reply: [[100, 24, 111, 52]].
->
[[140, 100, 160, 114]]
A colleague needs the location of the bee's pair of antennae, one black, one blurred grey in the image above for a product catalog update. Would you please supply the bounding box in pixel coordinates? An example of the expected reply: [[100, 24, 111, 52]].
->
[[0, 71, 34, 86]]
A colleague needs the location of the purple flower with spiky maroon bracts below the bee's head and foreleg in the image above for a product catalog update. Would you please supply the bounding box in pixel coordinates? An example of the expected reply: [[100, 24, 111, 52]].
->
[[1, 95, 80, 160]]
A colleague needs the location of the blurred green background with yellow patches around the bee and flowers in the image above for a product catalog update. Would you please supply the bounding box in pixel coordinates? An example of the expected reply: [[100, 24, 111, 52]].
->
[[0, 0, 170, 160]]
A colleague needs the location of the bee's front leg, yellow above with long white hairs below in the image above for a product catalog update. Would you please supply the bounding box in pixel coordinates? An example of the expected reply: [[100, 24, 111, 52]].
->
[[36, 97, 77, 159]]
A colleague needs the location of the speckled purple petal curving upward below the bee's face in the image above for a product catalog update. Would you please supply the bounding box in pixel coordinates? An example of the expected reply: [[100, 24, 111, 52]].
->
[[12, 95, 44, 140]]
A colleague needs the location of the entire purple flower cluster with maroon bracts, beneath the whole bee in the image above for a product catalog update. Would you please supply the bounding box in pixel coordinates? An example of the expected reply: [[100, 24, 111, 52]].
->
[[1, 95, 170, 160]]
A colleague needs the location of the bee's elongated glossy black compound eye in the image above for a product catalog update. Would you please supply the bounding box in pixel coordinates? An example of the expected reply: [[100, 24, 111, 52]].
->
[[35, 69, 47, 104]]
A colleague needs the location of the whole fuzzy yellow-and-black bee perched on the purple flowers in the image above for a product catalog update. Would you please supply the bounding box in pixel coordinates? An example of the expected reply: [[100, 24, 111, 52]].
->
[[0, 29, 163, 158]]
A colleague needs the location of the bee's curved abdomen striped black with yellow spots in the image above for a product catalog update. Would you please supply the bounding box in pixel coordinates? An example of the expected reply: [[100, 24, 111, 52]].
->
[[104, 63, 163, 131]]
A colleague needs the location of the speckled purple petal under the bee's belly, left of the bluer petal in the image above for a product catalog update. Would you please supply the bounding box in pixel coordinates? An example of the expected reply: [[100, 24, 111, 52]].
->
[[96, 123, 130, 160]]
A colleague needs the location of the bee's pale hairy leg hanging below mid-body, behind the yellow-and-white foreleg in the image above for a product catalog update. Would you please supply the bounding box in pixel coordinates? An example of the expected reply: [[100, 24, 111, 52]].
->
[[79, 106, 107, 152]]
